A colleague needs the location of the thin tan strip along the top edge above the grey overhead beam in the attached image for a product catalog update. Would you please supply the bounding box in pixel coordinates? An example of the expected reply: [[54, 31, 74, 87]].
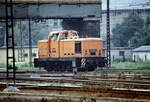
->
[[0, 0, 101, 3]]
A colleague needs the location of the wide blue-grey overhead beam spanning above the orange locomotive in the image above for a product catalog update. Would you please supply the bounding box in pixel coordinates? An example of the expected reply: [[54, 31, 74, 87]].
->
[[0, 3, 101, 19]]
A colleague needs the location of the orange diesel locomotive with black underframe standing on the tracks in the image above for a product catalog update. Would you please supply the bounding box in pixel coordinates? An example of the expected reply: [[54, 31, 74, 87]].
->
[[34, 30, 106, 72]]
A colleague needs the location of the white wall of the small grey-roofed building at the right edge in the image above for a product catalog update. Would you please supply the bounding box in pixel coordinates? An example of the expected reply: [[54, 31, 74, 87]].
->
[[132, 52, 150, 62]]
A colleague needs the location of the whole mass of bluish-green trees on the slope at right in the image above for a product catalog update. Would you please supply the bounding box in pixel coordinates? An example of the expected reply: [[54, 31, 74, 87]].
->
[[112, 13, 150, 47]]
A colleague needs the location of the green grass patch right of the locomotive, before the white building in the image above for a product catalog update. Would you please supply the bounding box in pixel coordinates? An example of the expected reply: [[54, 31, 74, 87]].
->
[[88, 61, 150, 75]]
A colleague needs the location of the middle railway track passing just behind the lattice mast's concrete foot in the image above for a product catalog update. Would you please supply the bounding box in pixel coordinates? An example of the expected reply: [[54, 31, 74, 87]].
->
[[0, 76, 150, 87]]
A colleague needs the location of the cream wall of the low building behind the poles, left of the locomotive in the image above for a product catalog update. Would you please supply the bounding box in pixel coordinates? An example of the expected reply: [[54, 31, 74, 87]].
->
[[0, 48, 38, 64]]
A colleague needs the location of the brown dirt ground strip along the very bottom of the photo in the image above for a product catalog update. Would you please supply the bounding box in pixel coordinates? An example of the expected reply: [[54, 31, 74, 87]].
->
[[0, 88, 150, 102]]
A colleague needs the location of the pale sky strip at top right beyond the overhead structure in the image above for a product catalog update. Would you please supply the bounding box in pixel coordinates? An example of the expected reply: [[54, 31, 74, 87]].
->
[[102, 0, 150, 10]]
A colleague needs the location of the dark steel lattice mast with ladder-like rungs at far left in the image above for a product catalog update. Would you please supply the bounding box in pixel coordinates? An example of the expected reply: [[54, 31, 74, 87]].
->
[[5, 0, 16, 87]]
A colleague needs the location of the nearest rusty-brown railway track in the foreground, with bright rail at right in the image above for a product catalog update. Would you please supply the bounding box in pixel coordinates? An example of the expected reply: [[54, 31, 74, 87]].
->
[[0, 81, 150, 102]]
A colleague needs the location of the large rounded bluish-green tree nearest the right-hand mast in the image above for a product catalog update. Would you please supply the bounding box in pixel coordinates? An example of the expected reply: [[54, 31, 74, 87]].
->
[[111, 13, 144, 47]]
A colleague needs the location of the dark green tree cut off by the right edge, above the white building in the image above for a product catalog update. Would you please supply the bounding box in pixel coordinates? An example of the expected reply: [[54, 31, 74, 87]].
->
[[132, 16, 150, 47]]
